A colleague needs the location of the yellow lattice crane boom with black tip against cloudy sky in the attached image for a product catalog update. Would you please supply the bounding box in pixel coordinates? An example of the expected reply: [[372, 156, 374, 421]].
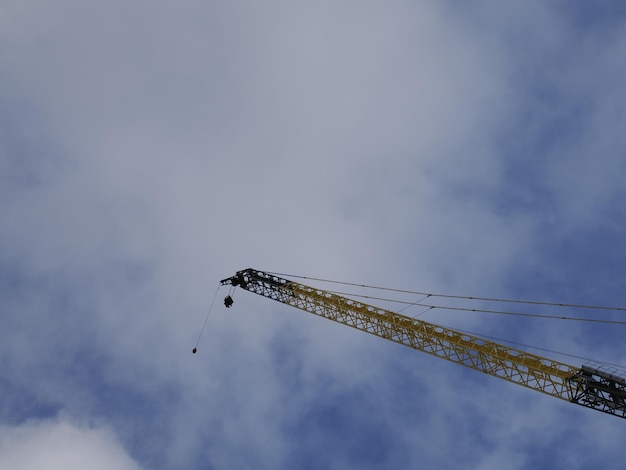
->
[[220, 269, 626, 418]]
